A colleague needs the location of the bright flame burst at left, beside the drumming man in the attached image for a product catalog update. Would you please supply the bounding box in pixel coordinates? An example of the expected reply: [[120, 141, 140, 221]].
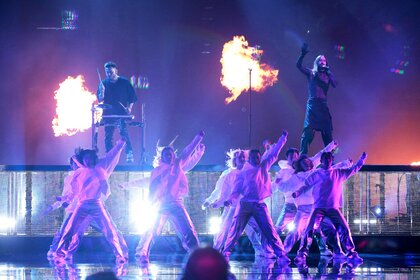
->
[[52, 75, 97, 137]]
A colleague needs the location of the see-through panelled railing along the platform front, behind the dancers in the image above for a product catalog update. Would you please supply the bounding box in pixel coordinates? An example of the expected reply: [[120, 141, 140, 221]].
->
[[0, 166, 420, 236]]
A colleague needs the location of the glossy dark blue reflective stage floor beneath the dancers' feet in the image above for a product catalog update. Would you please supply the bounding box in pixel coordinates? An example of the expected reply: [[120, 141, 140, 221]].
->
[[0, 253, 420, 280]]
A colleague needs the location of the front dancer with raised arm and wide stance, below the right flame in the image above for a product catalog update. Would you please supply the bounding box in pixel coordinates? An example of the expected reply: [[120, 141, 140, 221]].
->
[[223, 131, 289, 262]]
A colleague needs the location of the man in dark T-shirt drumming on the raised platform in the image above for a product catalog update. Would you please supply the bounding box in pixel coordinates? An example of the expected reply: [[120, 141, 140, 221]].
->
[[97, 61, 137, 163]]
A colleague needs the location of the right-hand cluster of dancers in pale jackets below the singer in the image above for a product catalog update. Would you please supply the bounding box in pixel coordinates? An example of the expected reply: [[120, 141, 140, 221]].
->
[[203, 136, 366, 262]]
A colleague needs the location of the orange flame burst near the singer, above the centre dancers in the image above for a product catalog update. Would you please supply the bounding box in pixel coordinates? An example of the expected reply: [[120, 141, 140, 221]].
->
[[220, 36, 279, 104]]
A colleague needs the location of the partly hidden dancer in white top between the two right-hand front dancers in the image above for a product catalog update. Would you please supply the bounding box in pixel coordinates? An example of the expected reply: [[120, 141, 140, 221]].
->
[[273, 148, 299, 234]]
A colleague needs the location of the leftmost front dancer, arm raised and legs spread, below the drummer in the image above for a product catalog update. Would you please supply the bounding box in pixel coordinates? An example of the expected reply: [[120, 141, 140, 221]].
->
[[55, 138, 128, 263]]
